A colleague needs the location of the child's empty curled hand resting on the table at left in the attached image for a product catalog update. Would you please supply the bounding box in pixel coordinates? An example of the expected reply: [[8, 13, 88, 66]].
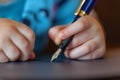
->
[[0, 19, 35, 62]]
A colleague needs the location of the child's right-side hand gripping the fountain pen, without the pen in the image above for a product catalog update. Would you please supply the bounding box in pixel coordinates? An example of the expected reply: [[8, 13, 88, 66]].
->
[[49, 16, 106, 60]]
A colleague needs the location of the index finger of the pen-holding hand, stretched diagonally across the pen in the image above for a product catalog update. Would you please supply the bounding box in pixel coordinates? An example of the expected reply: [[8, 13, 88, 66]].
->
[[58, 17, 91, 39]]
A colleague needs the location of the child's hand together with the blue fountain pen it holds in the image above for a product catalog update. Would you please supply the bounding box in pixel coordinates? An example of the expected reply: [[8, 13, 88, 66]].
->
[[49, 0, 105, 61]]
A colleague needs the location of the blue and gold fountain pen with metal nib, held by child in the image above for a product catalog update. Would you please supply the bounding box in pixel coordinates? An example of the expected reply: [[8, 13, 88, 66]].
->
[[50, 0, 96, 62]]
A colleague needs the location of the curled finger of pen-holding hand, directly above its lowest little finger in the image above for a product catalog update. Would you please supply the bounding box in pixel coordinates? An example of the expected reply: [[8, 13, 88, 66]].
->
[[65, 38, 99, 59]]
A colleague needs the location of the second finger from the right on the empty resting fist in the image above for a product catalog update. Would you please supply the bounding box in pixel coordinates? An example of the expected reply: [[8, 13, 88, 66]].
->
[[11, 31, 33, 61]]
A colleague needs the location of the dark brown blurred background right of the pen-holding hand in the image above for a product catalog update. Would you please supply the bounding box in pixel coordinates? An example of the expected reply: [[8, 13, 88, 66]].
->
[[95, 0, 120, 46]]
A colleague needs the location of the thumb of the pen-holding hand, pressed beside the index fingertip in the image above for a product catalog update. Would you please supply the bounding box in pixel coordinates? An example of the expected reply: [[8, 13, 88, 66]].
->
[[49, 26, 65, 45]]
